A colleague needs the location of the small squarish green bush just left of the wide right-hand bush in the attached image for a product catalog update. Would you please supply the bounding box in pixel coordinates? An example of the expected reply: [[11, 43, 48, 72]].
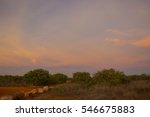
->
[[73, 72, 91, 83]]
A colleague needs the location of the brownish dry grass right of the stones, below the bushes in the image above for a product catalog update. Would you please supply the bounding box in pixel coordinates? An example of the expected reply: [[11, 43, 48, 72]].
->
[[32, 80, 150, 100]]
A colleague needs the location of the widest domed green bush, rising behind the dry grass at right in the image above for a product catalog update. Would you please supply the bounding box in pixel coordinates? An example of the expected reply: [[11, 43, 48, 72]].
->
[[93, 68, 129, 84]]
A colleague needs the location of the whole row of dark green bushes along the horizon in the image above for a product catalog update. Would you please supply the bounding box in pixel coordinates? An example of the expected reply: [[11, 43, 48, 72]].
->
[[0, 68, 150, 86]]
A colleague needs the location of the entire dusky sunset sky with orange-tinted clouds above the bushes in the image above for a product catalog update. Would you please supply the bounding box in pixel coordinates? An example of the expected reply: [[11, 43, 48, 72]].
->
[[0, 0, 150, 74]]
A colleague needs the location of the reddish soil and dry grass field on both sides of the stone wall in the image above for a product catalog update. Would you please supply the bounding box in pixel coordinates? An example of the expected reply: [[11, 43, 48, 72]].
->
[[0, 79, 150, 100]]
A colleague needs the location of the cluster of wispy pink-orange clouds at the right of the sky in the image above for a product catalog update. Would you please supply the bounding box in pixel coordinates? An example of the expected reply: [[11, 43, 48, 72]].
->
[[105, 29, 150, 47]]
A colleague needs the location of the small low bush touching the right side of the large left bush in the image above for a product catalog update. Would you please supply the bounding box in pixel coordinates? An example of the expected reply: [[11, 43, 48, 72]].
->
[[52, 73, 68, 84]]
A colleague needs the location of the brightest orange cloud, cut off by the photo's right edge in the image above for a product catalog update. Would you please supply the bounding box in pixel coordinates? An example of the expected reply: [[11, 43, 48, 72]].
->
[[133, 37, 150, 47]]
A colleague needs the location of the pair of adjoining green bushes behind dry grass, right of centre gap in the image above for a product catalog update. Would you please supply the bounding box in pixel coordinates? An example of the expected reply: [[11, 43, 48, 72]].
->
[[73, 68, 130, 87]]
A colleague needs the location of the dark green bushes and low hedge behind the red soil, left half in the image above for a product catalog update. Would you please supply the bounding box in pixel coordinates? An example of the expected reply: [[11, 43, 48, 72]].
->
[[0, 69, 68, 86]]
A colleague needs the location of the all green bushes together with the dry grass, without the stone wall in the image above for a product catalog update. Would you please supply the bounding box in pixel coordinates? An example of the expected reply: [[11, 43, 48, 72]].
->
[[0, 68, 150, 99]]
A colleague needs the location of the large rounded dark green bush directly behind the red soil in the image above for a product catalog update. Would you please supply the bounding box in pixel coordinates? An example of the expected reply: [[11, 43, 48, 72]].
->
[[24, 69, 51, 86]]
